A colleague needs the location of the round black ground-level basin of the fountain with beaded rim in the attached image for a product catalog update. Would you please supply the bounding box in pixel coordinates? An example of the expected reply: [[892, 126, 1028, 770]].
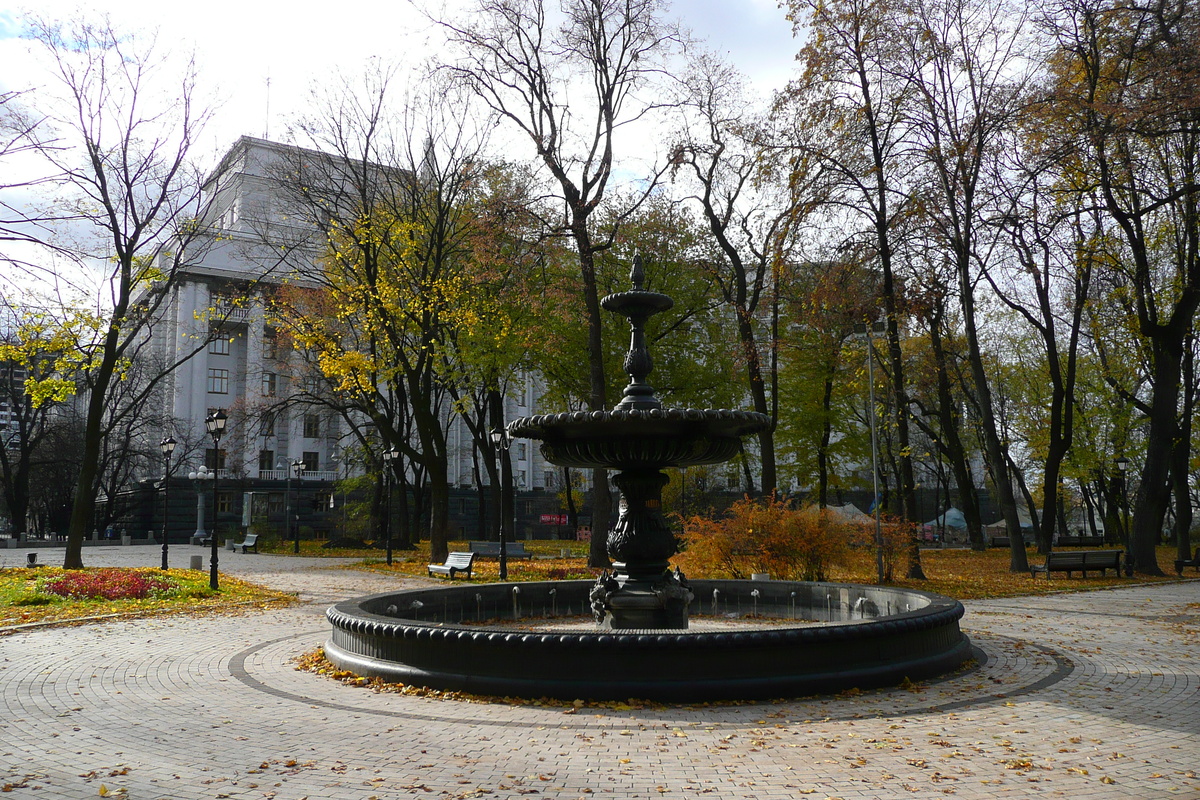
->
[[325, 581, 971, 702]]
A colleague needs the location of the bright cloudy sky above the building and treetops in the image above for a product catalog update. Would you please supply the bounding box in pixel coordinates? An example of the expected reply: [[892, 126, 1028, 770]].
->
[[0, 0, 798, 165]]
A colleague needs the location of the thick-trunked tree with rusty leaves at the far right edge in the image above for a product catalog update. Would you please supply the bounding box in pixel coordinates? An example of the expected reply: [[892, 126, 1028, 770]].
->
[[1044, 0, 1200, 575]]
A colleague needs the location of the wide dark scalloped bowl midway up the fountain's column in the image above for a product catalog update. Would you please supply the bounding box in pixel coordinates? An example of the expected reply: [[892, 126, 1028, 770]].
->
[[508, 408, 770, 470]]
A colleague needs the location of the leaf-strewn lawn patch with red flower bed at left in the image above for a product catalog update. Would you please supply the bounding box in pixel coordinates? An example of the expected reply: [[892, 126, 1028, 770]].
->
[[0, 566, 295, 627]]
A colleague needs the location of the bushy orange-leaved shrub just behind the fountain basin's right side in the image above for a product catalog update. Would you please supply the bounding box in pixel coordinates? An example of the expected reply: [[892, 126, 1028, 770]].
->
[[676, 495, 856, 581]]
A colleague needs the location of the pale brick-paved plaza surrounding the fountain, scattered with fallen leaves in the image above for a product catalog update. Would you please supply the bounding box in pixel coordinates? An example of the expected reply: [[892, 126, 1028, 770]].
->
[[0, 546, 1200, 800]]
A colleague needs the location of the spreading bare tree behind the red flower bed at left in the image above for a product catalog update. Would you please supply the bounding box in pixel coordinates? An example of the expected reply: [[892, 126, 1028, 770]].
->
[[5, 19, 229, 569]]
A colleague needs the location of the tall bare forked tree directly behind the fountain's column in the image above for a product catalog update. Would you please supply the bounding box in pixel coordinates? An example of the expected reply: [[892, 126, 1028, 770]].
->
[[440, 0, 680, 566]]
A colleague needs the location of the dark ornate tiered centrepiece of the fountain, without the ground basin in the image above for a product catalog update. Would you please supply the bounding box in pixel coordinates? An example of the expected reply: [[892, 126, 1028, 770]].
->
[[509, 257, 769, 630]]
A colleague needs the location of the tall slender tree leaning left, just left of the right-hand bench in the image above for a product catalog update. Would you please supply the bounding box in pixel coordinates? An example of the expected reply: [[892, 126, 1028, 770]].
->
[[896, 0, 1036, 572]]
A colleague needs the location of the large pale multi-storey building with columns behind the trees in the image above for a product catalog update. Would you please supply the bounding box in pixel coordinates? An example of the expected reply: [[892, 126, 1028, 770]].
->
[[144, 137, 556, 501]]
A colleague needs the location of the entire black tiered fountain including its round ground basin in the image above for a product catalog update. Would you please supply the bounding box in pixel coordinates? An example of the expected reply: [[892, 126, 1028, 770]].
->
[[325, 259, 971, 702]]
